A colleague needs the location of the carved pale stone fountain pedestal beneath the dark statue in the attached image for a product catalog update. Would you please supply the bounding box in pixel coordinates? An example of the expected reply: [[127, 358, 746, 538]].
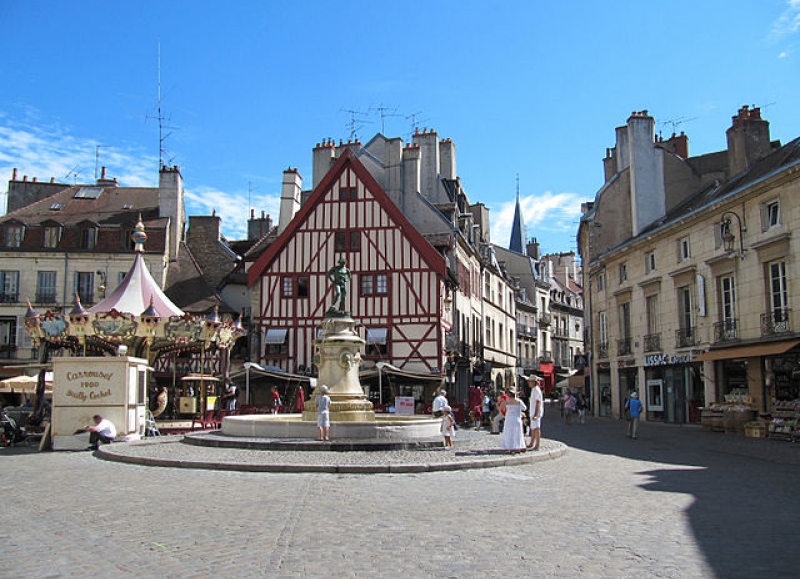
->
[[303, 313, 375, 423]]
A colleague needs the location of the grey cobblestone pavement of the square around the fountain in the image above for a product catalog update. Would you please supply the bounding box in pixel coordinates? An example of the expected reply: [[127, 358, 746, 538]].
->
[[0, 408, 800, 578]]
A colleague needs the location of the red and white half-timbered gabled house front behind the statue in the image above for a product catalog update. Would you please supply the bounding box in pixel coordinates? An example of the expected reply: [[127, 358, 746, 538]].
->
[[248, 150, 451, 376]]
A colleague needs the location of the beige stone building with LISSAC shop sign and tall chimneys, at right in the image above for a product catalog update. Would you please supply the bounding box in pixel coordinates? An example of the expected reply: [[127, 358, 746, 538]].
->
[[578, 107, 800, 423]]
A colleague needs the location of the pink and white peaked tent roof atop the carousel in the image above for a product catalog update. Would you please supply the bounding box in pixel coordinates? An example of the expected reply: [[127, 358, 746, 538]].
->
[[89, 252, 183, 318]]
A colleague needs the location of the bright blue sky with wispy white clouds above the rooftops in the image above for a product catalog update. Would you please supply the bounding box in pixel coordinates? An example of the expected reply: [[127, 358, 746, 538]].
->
[[0, 0, 800, 253]]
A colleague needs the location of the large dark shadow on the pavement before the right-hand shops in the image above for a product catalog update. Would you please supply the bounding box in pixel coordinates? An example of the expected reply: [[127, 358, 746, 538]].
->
[[543, 405, 800, 578]]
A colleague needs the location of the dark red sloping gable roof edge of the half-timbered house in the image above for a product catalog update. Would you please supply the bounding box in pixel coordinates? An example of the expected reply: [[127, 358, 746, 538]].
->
[[247, 149, 446, 287]]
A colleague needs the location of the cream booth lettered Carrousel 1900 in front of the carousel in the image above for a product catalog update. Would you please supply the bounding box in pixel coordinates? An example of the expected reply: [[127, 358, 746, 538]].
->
[[50, 356, 149, 450]]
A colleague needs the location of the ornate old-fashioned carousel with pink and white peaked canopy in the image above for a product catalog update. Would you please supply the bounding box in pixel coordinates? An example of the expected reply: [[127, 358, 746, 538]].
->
[[25, 219, 246, 448]]
